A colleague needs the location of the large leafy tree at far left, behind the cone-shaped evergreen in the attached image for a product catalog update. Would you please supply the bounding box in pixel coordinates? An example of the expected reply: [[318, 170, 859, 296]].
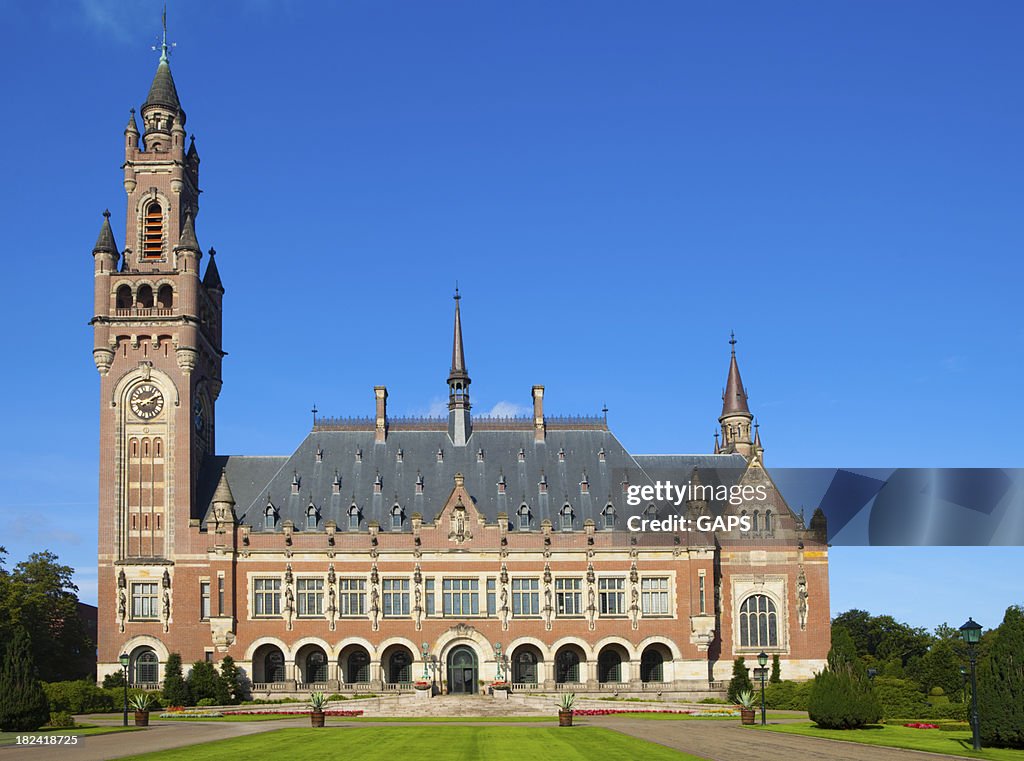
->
[[0, 548, 96, 682]]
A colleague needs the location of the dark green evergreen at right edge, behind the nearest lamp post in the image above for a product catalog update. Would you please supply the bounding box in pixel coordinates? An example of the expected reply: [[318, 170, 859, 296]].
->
[[978, 605, 1024, 749]]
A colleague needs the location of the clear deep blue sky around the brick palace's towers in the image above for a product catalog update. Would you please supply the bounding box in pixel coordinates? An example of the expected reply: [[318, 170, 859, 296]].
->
[[0, 0, 1024, 626]]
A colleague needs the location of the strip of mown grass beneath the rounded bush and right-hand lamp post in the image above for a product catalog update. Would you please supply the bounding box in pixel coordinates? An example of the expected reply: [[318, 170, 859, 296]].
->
[[753, 723, 1024, 761]]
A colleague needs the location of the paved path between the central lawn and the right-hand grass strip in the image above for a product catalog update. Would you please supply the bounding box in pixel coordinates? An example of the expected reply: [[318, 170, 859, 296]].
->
[[589, 717, 962, 761]]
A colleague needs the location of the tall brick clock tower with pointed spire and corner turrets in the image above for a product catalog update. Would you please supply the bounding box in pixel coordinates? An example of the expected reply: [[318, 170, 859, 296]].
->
[[90, 19, 224, 643]]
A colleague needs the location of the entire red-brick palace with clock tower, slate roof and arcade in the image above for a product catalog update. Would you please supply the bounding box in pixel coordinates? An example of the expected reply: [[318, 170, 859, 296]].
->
[[91, 40, 829, 695]]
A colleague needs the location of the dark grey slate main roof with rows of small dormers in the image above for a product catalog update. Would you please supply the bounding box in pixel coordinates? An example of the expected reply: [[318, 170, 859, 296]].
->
[[199, 429, 746, 531]]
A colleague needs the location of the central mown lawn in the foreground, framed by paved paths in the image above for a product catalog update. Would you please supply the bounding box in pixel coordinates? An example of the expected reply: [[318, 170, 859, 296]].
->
[[112, 726, 701, 761]]
